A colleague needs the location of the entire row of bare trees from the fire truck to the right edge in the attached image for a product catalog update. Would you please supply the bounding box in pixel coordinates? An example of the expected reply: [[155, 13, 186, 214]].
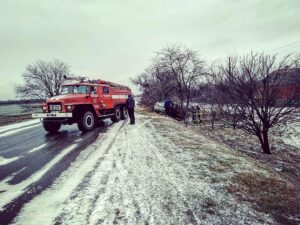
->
[[132, 45, 300, 154]]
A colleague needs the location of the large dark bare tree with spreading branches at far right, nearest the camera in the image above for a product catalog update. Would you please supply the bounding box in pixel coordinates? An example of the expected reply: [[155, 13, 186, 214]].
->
[[212, 53, 300, 154]]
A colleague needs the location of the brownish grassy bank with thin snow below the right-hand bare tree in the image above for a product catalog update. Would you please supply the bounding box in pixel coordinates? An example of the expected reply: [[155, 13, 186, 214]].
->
[[150, 110, 300, 225]]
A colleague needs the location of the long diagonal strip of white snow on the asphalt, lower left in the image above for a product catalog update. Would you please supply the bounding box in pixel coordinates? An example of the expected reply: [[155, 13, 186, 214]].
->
[[0, 144, 77, 210]]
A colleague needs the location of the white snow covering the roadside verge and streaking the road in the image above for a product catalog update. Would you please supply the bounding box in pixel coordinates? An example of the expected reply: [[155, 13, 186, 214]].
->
[[0, 112, 296, 225]]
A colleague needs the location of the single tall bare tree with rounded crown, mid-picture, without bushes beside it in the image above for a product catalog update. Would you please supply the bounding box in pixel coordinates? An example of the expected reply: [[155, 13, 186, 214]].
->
[[154, 46, 205, 109]]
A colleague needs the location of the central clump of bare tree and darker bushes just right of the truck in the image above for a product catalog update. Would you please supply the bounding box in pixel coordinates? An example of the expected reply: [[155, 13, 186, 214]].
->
[[132, 46, 205, 110]]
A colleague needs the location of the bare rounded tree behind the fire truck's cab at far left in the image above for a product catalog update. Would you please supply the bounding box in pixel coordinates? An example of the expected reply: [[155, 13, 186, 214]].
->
[[15, 60, 69, 99]]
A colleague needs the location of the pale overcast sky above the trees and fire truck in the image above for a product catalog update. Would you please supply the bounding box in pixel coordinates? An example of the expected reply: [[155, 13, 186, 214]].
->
[[0, 0, 300, 100]]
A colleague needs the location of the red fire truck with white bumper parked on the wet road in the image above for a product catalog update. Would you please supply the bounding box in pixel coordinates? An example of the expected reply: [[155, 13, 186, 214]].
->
[[32, 77, 131, 133]]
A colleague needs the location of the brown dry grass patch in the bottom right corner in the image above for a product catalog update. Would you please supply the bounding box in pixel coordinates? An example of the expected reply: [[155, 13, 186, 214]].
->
[[228, 172, 300, 225]]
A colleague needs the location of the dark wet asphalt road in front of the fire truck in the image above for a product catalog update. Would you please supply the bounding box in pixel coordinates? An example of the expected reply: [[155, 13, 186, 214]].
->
[[0, 122, 111, 225]]
